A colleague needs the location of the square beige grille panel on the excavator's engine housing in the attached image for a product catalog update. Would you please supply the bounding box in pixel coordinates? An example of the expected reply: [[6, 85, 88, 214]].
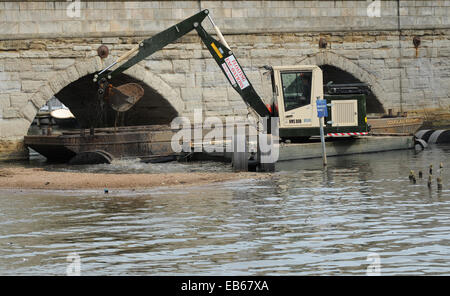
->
[[331, 100, 358, 126]]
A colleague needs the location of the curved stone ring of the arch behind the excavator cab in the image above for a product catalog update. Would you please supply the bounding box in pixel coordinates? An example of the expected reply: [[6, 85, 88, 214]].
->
[[299, 51, 389, 113]]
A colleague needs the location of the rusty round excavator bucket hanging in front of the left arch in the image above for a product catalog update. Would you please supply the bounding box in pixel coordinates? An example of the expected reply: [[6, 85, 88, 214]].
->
[[106, 83, 144, 112]]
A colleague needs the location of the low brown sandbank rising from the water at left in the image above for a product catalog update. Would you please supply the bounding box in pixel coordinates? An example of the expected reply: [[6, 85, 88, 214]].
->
[[0, 168, 268, 189]]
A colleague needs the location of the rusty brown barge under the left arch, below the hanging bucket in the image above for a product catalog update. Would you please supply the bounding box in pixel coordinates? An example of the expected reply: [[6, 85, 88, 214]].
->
[[24, 125, 176, 164]]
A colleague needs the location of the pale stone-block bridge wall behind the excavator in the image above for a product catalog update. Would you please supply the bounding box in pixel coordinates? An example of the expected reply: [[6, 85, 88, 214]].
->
[[0, 0, 450, 159]]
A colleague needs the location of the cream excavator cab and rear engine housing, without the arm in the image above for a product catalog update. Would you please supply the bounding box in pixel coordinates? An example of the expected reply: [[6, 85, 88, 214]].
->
[[269, 65, 368, 141]]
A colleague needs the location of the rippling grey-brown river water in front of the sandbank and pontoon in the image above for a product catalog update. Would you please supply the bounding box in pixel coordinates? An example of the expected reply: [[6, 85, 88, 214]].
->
[[0, 145, 450, 275]]
